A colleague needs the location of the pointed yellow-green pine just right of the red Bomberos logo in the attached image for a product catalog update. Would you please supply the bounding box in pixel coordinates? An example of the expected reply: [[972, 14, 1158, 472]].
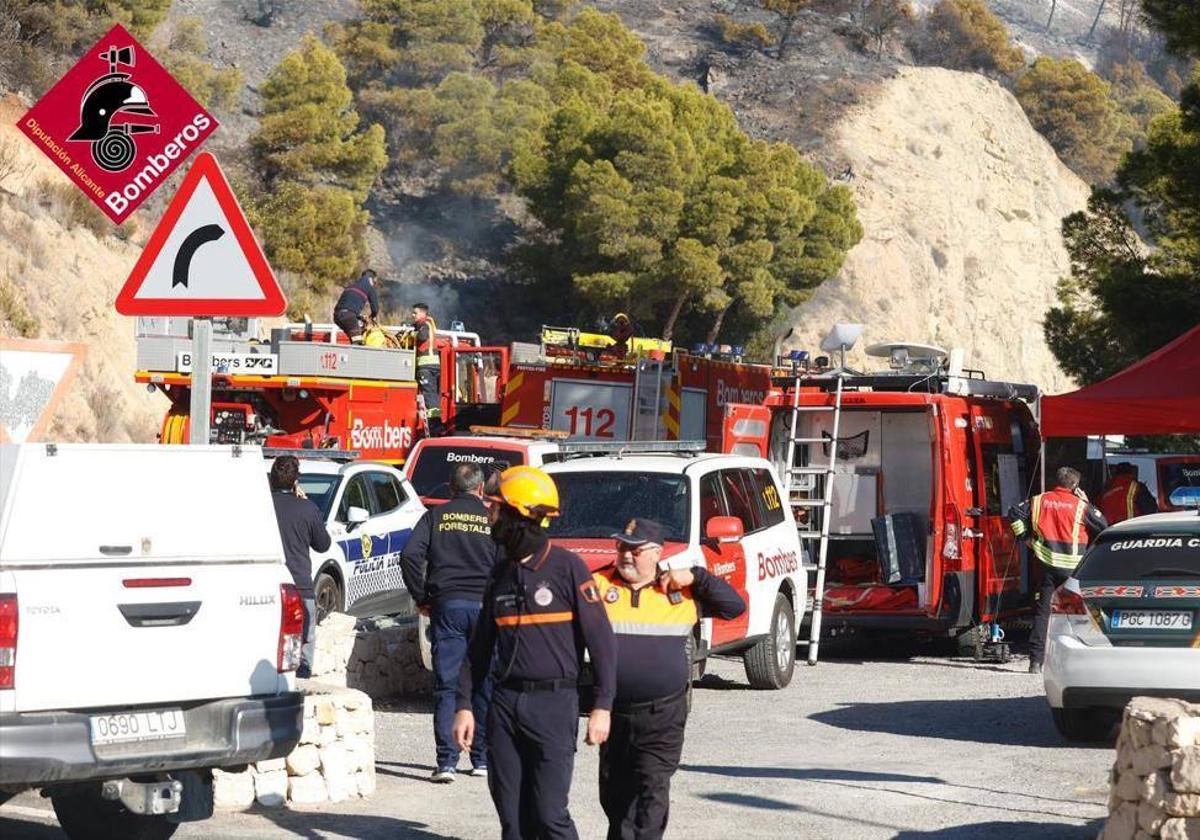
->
[[251, 35, 386, 197]]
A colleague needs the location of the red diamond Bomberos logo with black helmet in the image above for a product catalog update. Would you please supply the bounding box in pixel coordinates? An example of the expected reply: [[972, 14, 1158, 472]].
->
[[19, 24, 217, 224]]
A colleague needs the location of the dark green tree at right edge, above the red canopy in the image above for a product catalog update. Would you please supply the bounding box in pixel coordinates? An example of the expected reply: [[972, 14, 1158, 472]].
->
[[1045, 1, 1200, 384]]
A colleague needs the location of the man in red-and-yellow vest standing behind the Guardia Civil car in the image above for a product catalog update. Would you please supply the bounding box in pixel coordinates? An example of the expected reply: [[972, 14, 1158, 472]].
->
[[1008, 467, 1108, 673]]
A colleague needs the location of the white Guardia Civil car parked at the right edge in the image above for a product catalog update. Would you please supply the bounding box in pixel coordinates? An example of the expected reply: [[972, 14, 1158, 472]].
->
[[1043, 484, 1200, 740]]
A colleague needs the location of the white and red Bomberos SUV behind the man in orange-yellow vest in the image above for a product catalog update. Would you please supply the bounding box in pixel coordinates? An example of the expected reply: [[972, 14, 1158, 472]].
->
[[545, 443, 808, 689]]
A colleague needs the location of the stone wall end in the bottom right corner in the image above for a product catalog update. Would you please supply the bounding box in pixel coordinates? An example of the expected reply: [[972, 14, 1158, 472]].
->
[[1100, 697, 1200, 840]]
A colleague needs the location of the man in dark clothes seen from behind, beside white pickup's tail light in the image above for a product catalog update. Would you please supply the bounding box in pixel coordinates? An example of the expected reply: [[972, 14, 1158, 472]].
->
[[270, 455, 332, 677]]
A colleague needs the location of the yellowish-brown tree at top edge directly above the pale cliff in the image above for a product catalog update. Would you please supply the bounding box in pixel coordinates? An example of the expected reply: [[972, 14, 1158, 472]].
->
[[917, 0, 1025, 76]]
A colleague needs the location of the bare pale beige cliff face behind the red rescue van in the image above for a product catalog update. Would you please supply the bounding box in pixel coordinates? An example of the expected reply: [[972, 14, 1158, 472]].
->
[[777, 67, 1088, 392]]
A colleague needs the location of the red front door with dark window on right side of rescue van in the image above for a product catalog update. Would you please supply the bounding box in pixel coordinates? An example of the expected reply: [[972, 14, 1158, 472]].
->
[[962, 406, 1028, 622]]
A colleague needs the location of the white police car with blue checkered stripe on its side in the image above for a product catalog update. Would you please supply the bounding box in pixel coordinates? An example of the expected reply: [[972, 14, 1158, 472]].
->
[[300, 458, 425, 618]]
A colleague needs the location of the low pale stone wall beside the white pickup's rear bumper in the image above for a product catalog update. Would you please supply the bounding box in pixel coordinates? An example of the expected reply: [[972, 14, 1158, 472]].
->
[[212, 680, 376, 810]]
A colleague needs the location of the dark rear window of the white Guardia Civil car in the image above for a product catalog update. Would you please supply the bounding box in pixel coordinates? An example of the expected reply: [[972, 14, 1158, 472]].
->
[[1075, 532, 1200, 581]]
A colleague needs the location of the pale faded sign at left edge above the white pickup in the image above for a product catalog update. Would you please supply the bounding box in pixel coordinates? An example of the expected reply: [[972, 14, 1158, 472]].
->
[[0, 338, 88, 443]]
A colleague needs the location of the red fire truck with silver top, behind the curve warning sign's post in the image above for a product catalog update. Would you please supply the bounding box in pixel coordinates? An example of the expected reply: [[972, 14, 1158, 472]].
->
[[136, 318, 508, 463]]
